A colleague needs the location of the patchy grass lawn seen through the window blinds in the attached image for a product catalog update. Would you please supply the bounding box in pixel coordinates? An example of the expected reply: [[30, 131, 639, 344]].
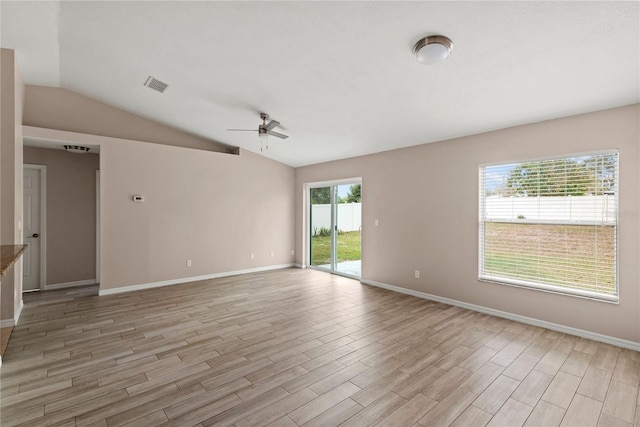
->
[[485, 223, 616, 293]]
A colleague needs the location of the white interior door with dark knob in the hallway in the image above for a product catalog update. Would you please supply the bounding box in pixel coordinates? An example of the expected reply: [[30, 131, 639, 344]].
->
[[22, 165, 43, 292]]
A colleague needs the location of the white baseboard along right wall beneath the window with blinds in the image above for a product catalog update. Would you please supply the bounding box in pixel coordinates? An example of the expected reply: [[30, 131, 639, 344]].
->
[[361, 280, 640, 351]]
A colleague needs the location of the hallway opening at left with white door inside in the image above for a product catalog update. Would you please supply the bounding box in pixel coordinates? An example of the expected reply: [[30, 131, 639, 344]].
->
[[22, 145, 100, 292]]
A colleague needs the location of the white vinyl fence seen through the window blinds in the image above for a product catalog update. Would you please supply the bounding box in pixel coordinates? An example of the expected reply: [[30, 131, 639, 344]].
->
[[485, 195, 616, 223]]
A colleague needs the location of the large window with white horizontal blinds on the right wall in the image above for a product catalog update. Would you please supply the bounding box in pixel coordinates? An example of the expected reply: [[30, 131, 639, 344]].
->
[[479, 152, 618, 301]]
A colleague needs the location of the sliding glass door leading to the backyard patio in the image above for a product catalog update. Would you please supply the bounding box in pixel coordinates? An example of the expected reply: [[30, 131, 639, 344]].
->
[[308, 182, 362, 278]]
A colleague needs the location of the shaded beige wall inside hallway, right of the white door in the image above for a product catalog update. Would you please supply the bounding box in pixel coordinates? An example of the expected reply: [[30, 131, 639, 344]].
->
[[24, 147, 100, 285]]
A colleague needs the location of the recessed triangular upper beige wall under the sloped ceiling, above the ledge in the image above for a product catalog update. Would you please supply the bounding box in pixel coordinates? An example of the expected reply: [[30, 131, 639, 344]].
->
[[23, 85, 237, 152]]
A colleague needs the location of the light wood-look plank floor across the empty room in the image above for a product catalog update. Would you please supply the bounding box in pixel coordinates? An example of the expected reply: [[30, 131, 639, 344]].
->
[[0, 269, 640, 427]]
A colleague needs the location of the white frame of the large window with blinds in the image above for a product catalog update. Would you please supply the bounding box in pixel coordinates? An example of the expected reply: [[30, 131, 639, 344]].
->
[[478, 149, 620, 304]]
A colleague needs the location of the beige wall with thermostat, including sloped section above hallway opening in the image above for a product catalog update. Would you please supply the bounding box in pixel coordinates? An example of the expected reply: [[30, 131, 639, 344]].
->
[[24, 86, 295, 291]]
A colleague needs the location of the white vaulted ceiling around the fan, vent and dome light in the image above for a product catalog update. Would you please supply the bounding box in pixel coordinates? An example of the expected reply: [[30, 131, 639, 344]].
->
[[0, 1, 640, 166]]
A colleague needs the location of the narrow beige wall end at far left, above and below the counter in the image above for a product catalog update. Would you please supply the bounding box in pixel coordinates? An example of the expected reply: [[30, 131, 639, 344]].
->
[[0, 49, 24, 320]]
